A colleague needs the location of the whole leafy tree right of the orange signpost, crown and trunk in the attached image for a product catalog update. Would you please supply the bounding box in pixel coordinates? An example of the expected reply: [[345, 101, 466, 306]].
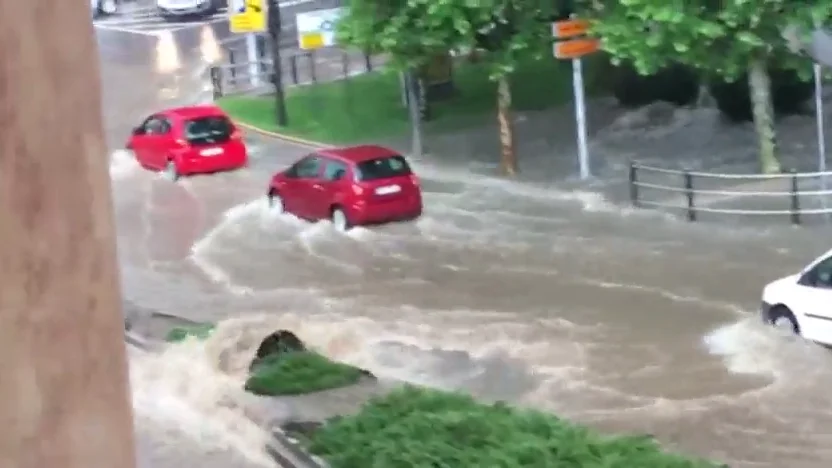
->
[[583, 0, 832, 173]]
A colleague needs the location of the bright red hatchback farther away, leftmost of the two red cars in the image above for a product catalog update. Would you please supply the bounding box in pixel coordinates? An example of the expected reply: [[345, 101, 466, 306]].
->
[[127, 106, 248, 180]]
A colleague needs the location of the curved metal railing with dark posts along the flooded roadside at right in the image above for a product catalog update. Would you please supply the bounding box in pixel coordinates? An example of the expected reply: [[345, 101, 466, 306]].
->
[[629, 162, 832, 225]]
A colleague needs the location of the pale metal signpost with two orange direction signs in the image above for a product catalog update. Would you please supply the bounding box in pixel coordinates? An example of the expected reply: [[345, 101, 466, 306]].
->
[[552, 18, 600, 179]]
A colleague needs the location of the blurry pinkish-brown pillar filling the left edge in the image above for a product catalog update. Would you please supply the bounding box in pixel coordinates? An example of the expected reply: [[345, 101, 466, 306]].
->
[[0, 0, 135, 468]]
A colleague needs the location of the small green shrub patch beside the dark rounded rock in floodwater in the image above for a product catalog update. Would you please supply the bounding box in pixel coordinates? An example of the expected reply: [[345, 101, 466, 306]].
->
[[245, 351, 365, 396]]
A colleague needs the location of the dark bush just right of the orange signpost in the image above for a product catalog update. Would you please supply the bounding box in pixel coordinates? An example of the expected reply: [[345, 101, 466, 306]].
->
[[612, 63, 699, 107]]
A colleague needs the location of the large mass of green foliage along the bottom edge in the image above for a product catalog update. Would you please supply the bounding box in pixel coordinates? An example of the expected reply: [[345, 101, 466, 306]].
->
[[310, 386, 719, 468]]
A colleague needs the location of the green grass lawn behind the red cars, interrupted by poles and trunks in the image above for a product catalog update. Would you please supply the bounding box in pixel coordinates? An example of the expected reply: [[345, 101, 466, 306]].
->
[[218, 54, 597, 144]]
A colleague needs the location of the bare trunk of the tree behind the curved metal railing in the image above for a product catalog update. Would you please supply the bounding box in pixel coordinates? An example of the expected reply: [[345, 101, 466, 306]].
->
[[748, 55, 780, 174]]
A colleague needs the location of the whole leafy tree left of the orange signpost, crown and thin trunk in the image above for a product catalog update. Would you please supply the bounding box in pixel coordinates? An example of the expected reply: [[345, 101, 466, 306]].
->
[[337, 0, 555, 175]]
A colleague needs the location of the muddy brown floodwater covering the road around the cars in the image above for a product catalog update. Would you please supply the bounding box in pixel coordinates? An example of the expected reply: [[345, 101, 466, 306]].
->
[[104, 23, 832, 468]]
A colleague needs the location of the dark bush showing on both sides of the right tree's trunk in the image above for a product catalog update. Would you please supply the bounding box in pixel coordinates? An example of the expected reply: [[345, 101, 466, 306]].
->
[[710, 69, 814, 122]]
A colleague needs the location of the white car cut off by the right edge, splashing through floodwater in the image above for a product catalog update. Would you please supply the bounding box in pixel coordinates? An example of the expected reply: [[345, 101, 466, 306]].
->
[[761, 250, 832, 346]]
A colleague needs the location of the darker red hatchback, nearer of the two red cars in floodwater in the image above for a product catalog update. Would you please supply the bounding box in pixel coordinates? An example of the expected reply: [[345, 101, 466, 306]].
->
[[268, 145, 422, 231]]
